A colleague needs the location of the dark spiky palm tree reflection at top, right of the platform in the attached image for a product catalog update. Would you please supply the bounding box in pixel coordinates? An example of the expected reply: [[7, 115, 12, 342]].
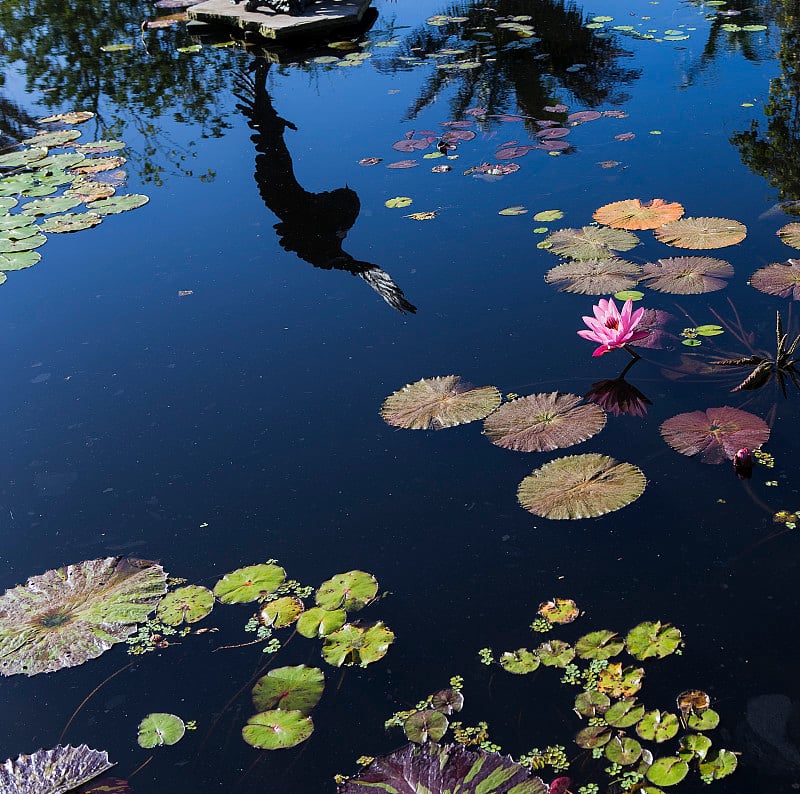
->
[[378, 0, 640, 123]]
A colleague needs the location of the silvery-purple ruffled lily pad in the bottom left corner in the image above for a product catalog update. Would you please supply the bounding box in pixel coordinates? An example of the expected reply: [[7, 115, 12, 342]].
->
[[0, 744, 114, 794]]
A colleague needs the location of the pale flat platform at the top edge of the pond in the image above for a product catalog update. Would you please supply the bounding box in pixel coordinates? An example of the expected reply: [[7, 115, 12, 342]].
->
[[188, 0, 371, 41]]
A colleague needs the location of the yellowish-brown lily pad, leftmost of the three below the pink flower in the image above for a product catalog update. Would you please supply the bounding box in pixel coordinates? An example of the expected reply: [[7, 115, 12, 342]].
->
[[381, 375, 502, 430]]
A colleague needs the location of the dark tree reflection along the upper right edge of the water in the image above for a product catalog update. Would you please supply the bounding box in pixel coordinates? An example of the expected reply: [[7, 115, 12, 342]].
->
[[730, 0, 800, 201]]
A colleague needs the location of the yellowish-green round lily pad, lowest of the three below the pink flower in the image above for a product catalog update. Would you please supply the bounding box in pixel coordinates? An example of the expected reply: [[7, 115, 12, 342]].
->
[[517, 453, 647, 519]]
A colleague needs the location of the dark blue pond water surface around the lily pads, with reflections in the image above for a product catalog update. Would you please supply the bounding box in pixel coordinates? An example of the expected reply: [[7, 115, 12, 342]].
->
[[0, 0, 800, 794]]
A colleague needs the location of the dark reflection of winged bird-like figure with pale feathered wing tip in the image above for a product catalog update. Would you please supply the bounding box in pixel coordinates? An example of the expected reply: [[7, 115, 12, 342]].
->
[[237, 58, 416, 313]]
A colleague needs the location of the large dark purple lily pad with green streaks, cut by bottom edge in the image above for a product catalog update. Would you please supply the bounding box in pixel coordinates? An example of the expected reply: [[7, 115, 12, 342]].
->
[[337, 744, 549, 794]]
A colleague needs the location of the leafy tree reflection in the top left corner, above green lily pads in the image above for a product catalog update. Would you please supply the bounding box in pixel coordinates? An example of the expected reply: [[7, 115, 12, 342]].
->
[[0, 0, 238, 184]]
